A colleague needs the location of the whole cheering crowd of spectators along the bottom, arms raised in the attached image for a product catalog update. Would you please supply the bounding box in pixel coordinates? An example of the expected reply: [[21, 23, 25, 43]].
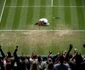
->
[[0, 44, 85, 70]]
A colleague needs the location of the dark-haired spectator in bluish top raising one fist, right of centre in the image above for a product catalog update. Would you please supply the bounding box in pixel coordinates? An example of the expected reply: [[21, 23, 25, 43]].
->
[[54, 44, 73, 70]]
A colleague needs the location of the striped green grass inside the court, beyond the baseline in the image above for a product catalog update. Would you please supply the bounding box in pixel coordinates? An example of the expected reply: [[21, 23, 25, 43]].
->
[[0, 0, 85, 30]]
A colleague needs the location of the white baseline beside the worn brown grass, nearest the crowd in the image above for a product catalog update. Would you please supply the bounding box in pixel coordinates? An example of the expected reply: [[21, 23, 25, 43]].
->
[[0, 30, 85, 32]]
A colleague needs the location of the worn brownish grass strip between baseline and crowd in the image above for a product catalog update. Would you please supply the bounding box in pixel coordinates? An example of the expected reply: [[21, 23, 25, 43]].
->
[[0, 30, 85, 55]]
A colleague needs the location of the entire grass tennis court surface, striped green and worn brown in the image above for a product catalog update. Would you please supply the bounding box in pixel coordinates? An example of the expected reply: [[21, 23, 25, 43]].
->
[[0, 0, 85, 54]]
